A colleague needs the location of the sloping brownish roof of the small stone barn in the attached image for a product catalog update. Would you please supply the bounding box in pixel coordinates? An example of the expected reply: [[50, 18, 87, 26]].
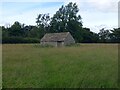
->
[[41, 32, 69, 42]]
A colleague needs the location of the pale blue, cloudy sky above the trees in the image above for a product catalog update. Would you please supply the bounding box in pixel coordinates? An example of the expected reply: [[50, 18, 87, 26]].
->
[[0, 0, 119, 33]]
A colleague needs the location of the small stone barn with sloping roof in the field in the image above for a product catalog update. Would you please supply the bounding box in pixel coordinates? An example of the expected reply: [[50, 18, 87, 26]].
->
[[40, 32, 75, 47]]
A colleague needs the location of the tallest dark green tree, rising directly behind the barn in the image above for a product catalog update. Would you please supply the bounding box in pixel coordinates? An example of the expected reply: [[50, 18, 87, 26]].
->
[[49, 2, 82, 42]]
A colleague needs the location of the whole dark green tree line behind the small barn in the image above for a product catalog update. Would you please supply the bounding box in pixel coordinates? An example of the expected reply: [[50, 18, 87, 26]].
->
[[1, 2, 120, 43]]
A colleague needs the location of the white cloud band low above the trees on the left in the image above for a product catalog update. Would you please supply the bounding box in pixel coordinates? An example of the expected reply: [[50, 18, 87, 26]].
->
[[0, 3, 59, 25]]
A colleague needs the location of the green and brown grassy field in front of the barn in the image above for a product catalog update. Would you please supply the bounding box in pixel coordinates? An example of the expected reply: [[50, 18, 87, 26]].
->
[[2, 44, 118, 88]]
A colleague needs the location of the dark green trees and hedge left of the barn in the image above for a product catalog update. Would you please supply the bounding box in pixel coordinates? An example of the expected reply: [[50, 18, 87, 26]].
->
[[2, 22, 44, 43]]
